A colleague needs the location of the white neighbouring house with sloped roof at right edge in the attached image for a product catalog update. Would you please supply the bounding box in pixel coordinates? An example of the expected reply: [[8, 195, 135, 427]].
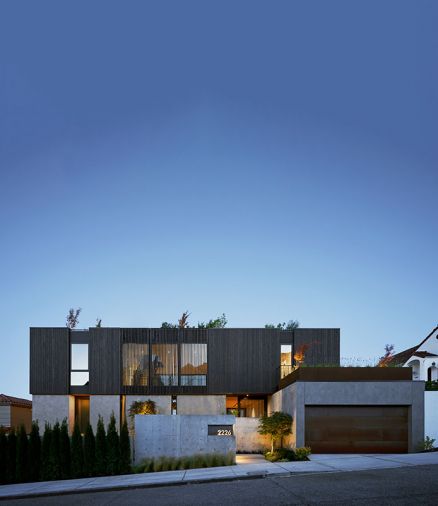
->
[[391, 326, 438, 381]]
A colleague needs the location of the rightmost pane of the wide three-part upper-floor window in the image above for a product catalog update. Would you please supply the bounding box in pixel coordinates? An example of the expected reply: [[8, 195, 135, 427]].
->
[[180, 343, 207, 387]]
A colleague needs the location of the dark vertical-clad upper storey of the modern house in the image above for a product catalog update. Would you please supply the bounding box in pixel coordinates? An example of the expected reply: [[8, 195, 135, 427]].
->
[[30, 327, 340, 395]]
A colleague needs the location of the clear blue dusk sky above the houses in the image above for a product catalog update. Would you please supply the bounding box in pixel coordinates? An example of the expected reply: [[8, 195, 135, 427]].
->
[[0, 0, 438, 397]]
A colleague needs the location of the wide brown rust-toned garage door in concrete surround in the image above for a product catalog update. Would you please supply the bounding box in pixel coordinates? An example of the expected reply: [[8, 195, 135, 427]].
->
[[305, 406, 408, 453]]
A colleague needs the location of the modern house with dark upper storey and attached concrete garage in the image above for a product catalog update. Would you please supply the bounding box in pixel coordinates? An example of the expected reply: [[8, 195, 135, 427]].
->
[[30, 327, 424, 452]]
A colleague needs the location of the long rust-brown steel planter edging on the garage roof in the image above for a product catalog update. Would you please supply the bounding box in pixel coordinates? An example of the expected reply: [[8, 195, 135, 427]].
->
[[279, 367, 412, 389]]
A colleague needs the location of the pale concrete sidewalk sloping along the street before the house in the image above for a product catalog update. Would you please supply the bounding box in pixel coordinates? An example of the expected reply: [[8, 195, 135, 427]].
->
[[0, 452, 438, 500]]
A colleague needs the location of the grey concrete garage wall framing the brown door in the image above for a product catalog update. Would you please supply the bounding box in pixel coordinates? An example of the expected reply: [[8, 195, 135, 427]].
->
[[268, 381, 424, 451]]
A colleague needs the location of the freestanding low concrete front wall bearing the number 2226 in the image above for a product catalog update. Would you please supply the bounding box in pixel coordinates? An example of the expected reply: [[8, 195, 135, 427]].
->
[[134, 415, 236, 463]]
